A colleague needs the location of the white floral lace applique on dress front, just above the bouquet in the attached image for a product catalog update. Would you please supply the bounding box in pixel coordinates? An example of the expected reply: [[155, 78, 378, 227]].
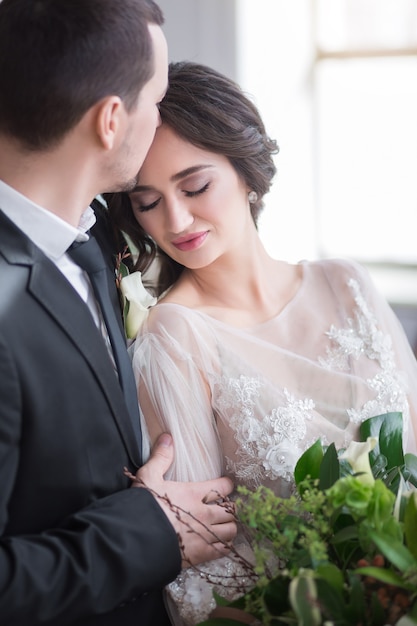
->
[[217, 375, 314, 487]]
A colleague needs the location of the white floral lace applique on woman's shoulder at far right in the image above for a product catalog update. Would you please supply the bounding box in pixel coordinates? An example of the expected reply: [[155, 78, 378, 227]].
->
[[319, 278, 409, 424]]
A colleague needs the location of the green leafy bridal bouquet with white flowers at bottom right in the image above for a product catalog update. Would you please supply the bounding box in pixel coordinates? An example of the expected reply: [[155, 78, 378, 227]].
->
[[197, 413, 417, 626]]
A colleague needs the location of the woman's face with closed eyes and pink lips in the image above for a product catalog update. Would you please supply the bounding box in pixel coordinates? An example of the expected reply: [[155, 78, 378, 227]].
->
[[129, 124, 253, 269]]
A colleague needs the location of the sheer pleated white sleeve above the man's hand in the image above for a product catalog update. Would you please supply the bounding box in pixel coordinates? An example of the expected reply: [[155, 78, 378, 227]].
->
[[133, 306, 223, 481]]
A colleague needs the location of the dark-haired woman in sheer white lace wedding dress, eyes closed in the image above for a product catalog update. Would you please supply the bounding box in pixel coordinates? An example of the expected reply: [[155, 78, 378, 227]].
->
[[107, 63, 417, 624]]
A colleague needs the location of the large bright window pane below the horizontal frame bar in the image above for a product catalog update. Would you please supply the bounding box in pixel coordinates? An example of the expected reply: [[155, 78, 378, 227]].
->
[[315, 57, 417, 262]]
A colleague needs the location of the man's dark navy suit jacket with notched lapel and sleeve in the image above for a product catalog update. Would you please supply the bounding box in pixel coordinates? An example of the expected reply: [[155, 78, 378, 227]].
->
[[0, 207, 180, 626]]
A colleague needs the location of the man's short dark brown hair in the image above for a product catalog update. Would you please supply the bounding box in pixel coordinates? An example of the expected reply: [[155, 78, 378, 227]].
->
[[0, 0, 163, 150]]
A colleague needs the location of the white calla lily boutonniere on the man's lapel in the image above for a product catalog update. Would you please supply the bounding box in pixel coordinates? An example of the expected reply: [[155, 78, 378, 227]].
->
[[116, 248, 157, 339]]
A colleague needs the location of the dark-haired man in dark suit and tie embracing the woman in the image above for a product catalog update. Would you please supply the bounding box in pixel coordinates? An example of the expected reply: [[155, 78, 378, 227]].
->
[[0, 0, 235, 626]]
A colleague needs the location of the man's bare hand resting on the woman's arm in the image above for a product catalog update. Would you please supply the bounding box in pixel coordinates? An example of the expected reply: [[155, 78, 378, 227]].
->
[[133, 433, 237, 566]]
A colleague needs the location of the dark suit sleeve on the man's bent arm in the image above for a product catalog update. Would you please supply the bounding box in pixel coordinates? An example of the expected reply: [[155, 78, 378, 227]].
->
[[0, 338, 181, 626]]
